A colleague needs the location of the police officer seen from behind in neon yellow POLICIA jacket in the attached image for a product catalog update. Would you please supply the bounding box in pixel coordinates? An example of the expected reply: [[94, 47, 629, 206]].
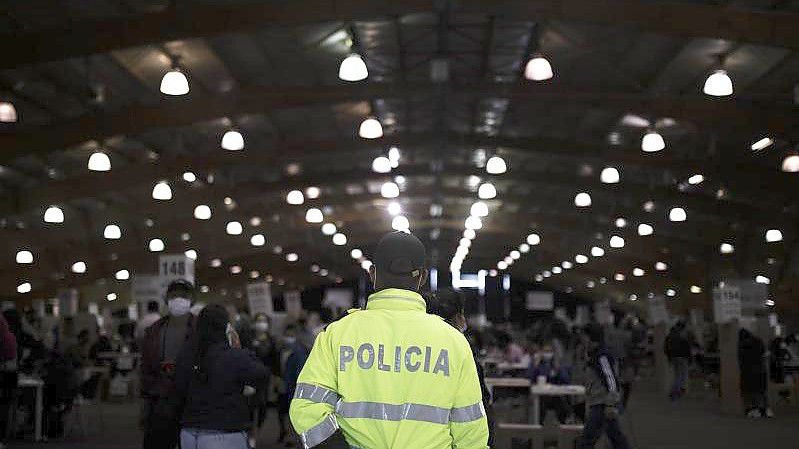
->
[[290, 232, 488, 449]]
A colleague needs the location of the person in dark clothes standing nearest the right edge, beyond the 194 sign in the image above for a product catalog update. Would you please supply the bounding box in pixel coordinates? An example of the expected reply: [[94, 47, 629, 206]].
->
[[738, 328, 774, 418]]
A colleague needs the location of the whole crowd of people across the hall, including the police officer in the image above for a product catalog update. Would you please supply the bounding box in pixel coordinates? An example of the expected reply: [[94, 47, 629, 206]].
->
[[0, 233, 799, 449]]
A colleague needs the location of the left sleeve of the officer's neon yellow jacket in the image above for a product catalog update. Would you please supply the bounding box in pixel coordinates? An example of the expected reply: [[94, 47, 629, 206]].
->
[[289, 331, 339, 448]]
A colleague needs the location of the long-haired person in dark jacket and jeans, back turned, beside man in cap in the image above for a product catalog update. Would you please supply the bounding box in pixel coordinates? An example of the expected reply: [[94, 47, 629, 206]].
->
[[175, 304, 268, 449]]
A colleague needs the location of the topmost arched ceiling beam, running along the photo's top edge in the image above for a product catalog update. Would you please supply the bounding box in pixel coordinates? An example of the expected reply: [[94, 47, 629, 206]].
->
[[0, 0, 799, 69]]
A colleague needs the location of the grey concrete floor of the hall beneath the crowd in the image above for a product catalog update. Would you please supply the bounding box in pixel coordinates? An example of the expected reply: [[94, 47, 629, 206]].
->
[[8, 380, 799, 449]]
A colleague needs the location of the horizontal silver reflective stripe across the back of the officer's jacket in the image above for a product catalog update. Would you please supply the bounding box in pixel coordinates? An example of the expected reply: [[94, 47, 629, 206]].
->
[[336, 401, 449, 424]]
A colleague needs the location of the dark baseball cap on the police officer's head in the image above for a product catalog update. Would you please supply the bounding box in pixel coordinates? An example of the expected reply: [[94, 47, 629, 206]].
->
[[374, 231, 427, 277]]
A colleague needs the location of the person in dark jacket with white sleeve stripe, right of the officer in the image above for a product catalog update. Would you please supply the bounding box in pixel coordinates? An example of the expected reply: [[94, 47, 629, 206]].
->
[[577, 325, 630, 449]]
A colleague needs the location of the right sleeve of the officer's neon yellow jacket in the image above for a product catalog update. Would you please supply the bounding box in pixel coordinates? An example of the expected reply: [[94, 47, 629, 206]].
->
[[449, 340, 488, 449]]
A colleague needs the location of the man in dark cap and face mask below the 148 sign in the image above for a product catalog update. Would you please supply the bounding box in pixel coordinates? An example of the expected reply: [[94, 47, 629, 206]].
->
[[140, 279, 195, 449]]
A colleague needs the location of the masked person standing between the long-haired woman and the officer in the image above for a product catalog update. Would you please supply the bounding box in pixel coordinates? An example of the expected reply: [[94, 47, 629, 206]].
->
[[245, 313, 280, 447]]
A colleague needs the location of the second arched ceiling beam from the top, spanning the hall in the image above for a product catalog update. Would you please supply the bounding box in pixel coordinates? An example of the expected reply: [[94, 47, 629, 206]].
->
[[0, 82, 799, 162]]
